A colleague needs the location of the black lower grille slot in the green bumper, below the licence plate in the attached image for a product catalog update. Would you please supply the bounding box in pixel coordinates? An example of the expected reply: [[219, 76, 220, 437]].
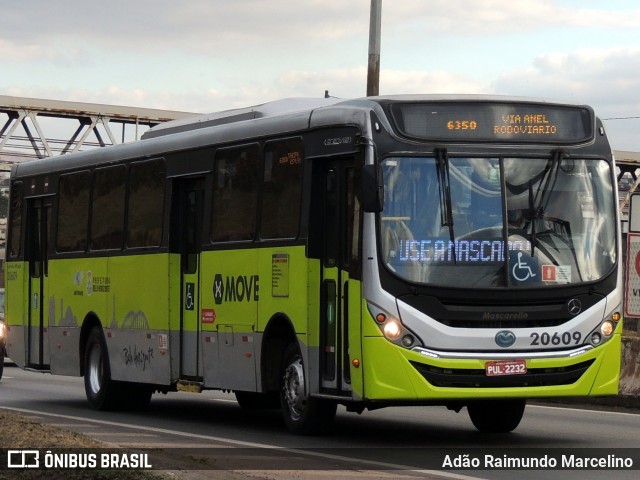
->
[[411, 360, 593, 388]]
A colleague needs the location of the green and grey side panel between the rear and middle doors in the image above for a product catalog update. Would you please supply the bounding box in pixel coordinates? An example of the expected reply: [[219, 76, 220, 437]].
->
[[24, 254, 170, 383]]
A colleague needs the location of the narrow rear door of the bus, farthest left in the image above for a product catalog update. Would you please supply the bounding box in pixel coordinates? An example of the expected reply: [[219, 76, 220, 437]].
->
[[26, 198, 54, 370]]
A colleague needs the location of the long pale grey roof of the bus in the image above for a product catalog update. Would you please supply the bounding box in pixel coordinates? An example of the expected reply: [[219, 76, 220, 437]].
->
[[7, 94, 596, 178]]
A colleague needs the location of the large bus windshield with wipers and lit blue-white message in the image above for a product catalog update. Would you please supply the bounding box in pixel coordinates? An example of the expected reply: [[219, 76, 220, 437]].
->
[[379, 156, 616, 288]]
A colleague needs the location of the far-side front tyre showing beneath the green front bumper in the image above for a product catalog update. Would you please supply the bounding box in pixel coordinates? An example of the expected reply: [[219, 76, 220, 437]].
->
[[467, 400, 526, 433]]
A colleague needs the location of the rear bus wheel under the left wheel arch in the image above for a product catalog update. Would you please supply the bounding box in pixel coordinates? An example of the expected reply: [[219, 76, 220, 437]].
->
[[84, 327, 119, 410]]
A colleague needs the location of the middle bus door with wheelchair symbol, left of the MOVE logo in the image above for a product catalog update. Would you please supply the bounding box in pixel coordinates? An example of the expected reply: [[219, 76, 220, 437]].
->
[[172, 178, 204, 381]]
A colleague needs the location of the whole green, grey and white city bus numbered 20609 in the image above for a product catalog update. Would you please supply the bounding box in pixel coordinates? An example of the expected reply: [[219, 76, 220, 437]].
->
[[6, 95, 623, 434]]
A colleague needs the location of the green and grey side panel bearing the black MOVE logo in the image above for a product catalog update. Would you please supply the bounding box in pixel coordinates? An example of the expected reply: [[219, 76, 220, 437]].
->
[[200, 246, 309, 391]]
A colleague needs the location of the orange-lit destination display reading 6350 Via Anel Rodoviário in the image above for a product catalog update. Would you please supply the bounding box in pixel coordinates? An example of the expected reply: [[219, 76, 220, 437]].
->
[[391, 102, 595, 144]]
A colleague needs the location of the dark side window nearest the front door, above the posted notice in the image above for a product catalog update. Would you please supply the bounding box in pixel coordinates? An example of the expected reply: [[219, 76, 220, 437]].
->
[[260, 138, 304, 238]]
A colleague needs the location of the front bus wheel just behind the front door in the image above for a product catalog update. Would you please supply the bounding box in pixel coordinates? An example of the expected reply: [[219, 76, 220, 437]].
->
[[280, 342, 337, 435]]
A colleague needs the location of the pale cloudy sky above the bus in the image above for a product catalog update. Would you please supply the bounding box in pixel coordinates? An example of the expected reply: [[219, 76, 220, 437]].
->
[[0, 0, 640, 152]]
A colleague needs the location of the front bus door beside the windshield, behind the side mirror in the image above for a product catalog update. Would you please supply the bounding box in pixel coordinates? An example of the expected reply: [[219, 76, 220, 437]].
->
[[319, 158, 359, 394]]
